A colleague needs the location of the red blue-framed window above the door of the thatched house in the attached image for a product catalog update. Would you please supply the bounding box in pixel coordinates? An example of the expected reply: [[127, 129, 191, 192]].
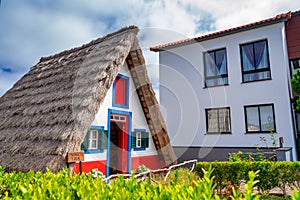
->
[[112, 74, 129, 108]]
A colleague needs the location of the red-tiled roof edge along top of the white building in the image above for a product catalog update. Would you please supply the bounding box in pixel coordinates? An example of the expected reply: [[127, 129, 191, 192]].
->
[[150, 10, 300, 51]]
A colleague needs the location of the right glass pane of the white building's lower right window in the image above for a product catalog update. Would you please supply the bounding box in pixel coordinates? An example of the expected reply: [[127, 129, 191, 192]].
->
[[259, 106, 274, 131]]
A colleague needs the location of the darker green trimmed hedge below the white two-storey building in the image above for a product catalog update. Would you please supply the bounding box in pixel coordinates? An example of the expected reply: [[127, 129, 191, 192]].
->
[[195, 161, 300, 196]]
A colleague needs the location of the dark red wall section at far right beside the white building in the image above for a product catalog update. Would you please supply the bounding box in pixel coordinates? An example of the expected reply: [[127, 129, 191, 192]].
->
[[285, 15, 300, 60]]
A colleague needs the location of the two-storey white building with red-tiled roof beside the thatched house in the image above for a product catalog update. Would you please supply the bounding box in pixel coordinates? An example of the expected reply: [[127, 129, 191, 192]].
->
[[150, 11, 300, 161]]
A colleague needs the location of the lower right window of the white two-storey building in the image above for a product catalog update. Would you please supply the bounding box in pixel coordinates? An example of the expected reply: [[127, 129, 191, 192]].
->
[[244, 104, 276, 133]]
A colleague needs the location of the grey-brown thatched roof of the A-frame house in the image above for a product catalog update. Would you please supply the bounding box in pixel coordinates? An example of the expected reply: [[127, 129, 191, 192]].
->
[[0, 26, 175, 171]]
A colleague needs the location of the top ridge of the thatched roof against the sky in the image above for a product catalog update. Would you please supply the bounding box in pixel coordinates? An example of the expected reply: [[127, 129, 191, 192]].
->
[[39, 25, 139, 62]]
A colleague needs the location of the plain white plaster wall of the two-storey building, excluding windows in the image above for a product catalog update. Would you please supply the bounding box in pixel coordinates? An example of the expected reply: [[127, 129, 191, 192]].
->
[[159, 23, 296, 159]]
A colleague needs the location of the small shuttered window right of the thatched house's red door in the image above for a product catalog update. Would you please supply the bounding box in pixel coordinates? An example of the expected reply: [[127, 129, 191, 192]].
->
[[131, 130, 149, 151]]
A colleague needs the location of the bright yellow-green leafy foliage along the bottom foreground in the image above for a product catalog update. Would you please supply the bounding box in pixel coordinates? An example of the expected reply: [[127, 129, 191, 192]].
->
[[0, 167, 299, 200]]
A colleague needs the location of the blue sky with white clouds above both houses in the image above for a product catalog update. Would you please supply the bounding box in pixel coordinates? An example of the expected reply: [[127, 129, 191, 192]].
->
[[0, 0, 300, 96]]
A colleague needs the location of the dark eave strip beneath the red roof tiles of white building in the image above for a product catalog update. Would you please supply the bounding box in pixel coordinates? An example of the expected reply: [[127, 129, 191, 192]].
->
[[150, 18, 288, 52]]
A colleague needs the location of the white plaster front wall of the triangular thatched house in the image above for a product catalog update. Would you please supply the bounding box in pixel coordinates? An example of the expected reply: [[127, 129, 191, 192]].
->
[[85, 63, 157, 161]]
